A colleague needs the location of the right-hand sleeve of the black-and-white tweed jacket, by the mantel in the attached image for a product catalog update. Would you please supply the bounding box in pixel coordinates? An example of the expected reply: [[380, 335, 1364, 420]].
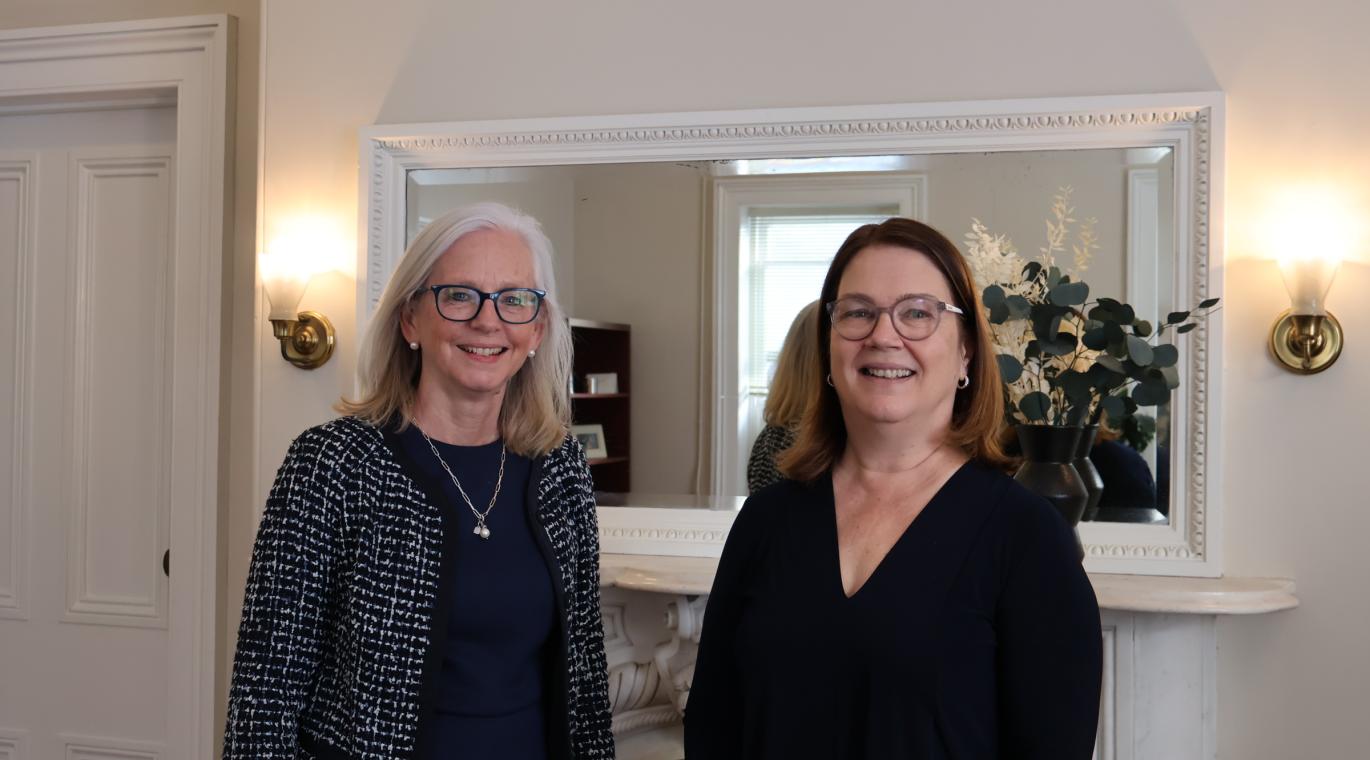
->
[[569, 451, 614, 760]]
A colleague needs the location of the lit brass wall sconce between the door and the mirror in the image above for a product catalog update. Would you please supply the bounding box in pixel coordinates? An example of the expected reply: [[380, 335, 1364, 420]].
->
[[259, 251, 334, 370]]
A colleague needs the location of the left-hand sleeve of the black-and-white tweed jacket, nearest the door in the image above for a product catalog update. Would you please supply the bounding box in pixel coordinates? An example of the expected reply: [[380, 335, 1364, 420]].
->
[[223, 431, 343, 760]]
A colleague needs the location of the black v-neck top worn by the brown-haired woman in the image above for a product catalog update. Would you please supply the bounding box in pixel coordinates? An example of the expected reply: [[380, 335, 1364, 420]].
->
[[685, 463, 1103, 760]]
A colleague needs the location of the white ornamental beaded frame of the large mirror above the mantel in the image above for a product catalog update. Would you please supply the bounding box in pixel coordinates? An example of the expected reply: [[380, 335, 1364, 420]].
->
[[358, 93, 1223, 577]]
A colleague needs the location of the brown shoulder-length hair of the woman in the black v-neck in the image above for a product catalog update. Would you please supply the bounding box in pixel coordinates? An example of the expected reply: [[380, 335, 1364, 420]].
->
[[777, 216, 1010, 482]]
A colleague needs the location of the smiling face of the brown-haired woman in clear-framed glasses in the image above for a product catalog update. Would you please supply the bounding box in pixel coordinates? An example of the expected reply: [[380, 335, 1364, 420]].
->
[[829, 245, 970, 429]]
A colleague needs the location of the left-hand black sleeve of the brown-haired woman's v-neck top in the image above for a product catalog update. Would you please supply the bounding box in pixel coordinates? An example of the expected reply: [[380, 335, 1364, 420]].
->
[[685, 497, 762, 760]]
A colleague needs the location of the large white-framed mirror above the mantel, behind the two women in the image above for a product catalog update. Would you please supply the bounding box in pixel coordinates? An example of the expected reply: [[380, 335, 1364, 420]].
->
[[360, 96, 1221, 574]]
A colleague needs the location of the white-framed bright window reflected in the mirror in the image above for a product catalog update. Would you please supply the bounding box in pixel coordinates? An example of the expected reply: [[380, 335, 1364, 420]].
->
[[711, 173, 926, 496]]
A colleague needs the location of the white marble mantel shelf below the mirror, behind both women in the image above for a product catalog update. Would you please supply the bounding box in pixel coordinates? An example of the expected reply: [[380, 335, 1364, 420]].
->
[[600, 555, 1299, 615]]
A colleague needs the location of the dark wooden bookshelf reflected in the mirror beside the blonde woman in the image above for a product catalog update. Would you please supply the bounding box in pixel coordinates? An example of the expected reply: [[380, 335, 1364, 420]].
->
[[571, 319, 633, 493]]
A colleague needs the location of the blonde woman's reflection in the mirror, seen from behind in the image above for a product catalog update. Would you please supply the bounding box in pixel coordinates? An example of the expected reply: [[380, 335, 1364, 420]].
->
[[747, 301, 819, 493]]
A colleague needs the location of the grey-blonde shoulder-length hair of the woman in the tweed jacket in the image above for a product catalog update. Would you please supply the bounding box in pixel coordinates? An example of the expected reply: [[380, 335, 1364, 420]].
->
[[337, 203, 571, 457]]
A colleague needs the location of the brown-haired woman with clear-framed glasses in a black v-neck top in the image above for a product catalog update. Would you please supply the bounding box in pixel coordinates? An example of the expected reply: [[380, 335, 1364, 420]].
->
[[685, 218, 1103, 760]]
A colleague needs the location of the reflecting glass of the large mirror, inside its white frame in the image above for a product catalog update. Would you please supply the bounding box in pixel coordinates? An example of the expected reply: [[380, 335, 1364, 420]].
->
[[406, 148, 1175, 522]]
